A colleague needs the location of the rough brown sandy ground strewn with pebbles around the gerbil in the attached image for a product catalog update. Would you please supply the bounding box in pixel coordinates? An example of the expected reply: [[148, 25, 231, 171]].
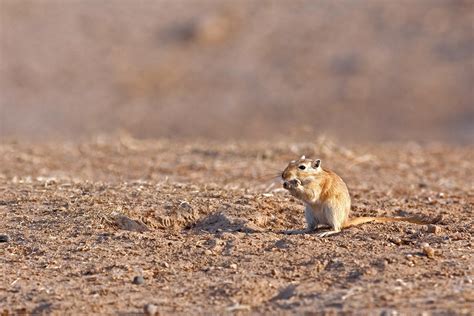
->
[[0, 137, 474, 315]]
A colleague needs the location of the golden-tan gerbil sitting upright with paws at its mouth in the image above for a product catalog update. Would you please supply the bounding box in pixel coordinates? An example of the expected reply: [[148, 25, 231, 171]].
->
[[282, 156, 441, 237]]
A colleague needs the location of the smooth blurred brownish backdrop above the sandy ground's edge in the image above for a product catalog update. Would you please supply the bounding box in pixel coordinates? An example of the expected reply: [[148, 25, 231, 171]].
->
[[0, 0, 474, 144]]
